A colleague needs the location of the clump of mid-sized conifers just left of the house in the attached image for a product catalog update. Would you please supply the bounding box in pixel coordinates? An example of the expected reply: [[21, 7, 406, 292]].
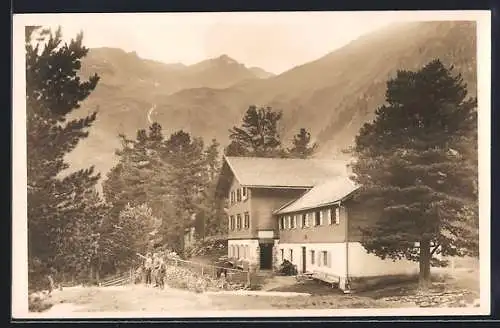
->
[[103, 123, 208, 252]]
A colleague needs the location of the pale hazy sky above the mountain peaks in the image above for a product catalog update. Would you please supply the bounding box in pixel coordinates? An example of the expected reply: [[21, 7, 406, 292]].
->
[[19, 12, 484, 73]]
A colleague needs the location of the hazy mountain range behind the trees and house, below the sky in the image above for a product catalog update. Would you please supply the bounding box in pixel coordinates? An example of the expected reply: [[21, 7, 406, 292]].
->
[[63, 21, 477, 179]]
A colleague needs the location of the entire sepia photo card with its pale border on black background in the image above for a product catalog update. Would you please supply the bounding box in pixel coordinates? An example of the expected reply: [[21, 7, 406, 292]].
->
[[12, 11, 491, 319]]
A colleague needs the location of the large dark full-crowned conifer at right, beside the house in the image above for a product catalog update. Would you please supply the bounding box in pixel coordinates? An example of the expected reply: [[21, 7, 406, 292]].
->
[[353, 60, 479, 289]]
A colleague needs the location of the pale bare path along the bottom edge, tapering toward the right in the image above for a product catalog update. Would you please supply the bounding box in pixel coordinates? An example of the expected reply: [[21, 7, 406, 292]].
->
[[46, 285, 403, 316]]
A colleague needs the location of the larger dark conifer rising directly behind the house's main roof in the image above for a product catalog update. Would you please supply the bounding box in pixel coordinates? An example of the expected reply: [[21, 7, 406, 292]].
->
[[226, 106, 285, 157]]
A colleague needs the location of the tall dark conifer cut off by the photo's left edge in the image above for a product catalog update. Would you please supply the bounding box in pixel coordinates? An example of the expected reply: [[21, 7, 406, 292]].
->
[[25, 26, 103, 284]]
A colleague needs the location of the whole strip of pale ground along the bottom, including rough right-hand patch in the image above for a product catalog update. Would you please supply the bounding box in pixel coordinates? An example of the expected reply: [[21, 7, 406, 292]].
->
[[38, 268, 478, 317]]
